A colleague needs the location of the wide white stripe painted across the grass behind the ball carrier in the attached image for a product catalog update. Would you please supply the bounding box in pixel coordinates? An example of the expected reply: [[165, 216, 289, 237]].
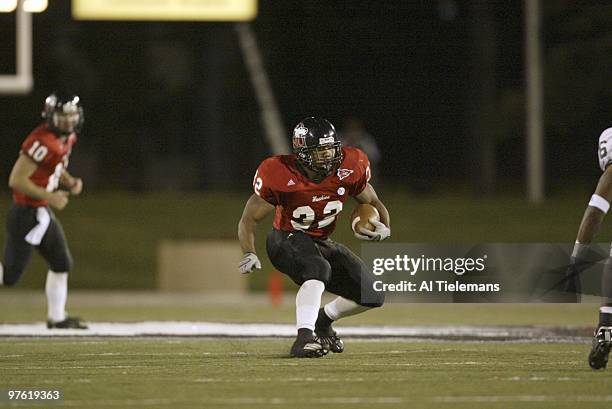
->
[[0, 321, 586, 342]]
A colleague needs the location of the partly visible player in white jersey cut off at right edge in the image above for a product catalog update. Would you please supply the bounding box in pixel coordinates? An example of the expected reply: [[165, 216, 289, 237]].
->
[[566, 128, 612, 369]]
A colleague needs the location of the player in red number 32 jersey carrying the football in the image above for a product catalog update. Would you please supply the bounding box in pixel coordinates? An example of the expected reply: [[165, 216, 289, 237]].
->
[[238, 117, 391, 358]]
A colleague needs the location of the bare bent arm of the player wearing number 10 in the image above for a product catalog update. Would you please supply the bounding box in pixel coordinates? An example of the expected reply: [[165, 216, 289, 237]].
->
[[9, 153, 68, 210]]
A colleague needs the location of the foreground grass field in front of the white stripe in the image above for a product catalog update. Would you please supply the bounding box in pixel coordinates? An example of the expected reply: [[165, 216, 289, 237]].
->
[[0, 339, 612, 409]]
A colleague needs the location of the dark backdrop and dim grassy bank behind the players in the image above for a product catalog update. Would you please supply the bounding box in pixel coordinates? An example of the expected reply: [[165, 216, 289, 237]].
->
[[0, 0, 612, 288]]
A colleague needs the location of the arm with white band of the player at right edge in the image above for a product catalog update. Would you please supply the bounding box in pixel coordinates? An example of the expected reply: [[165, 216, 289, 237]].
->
[[576, 166, 612, 243]]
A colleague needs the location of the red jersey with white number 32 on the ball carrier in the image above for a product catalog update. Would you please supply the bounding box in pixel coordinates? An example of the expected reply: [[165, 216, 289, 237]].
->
[[253, 147, 370, 238]]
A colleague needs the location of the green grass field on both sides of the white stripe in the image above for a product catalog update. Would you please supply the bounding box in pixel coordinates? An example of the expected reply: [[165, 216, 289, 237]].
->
[[0, 291, 612, 409]]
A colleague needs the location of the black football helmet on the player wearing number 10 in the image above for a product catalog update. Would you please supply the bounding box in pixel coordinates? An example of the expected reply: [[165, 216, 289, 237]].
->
[[42, 92, 85, 135]]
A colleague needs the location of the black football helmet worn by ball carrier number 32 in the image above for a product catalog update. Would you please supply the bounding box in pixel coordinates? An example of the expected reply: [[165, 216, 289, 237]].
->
[[293, 117, 343, 177]]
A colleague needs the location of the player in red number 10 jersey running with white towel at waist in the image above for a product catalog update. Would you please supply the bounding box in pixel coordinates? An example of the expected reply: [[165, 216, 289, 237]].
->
[[0, 94, 87, 329]]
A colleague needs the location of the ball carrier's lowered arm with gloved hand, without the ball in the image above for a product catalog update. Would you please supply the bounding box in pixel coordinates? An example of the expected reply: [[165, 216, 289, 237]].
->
[[238, 194, 274, 273]]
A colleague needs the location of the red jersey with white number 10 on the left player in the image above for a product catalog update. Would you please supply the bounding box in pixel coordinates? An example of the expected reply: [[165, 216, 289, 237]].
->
[[13, 124, 77, 207]]
